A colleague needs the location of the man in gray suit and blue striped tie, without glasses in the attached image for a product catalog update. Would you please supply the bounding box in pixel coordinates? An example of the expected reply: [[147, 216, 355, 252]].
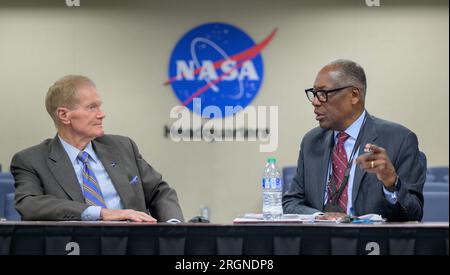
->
[[11, 75, 183, 222]]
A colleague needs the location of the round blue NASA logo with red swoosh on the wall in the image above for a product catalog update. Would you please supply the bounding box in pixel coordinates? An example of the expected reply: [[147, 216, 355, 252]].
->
[[165, 23, 276, 116]]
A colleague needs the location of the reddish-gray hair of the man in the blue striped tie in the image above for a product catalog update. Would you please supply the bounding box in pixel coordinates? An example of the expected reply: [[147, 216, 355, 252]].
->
[[45, 75, 95, 128]]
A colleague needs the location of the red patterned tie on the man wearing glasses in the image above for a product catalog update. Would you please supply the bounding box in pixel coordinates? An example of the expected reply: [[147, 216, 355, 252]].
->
[[328, 132, 350, 212]]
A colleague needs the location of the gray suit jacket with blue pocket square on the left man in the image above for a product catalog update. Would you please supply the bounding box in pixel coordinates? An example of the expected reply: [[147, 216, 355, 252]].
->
[[11, 135, 183, 221]]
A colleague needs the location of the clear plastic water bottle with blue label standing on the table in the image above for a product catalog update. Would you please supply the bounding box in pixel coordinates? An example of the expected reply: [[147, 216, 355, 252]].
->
[[262, 158, 283, 220]]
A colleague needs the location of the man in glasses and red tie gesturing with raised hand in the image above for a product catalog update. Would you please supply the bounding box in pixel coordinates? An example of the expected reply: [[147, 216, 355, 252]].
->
[[283, 59, 426, 221]]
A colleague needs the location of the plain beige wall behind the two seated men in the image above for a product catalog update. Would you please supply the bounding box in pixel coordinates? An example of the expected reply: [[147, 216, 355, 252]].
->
[[0, 0, 449, 222]]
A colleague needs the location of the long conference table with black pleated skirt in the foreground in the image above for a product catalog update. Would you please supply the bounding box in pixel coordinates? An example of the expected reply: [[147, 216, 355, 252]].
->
[[0, 221, 449, 255]]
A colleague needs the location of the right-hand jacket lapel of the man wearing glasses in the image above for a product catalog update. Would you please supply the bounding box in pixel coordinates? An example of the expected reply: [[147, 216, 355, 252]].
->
[[352, 113, 377, 205]]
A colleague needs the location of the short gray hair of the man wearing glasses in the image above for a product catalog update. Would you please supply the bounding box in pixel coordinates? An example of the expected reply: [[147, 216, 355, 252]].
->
[[326, 59, 367, 100]]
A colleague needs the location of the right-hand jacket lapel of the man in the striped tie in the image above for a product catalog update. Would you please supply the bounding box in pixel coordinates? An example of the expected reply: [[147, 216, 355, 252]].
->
[[92, 140, 138, 209]]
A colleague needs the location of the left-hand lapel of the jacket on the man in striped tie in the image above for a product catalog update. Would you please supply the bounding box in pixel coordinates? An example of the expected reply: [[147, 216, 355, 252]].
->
[[47, 136, 84, 203]]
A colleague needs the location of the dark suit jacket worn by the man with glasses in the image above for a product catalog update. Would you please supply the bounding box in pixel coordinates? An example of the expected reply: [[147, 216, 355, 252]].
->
[[283, 114, 426, 221]]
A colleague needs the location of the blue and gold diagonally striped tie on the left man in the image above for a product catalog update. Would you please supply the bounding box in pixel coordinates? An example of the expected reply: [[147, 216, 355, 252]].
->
[[77, 151, 106, 208]]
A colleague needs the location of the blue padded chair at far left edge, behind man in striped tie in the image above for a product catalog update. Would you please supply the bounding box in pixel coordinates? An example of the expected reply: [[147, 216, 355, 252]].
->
[[0, 173, 20, 221]]
